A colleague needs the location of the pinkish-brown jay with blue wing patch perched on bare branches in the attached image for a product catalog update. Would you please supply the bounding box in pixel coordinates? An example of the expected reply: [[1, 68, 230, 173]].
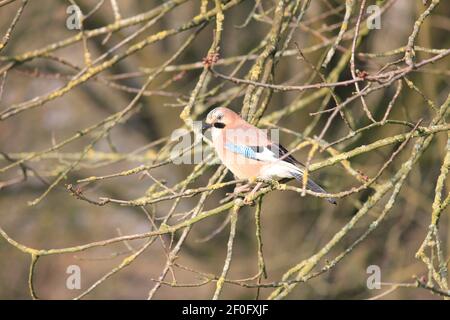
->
[[202, 107, 337, 204]]
